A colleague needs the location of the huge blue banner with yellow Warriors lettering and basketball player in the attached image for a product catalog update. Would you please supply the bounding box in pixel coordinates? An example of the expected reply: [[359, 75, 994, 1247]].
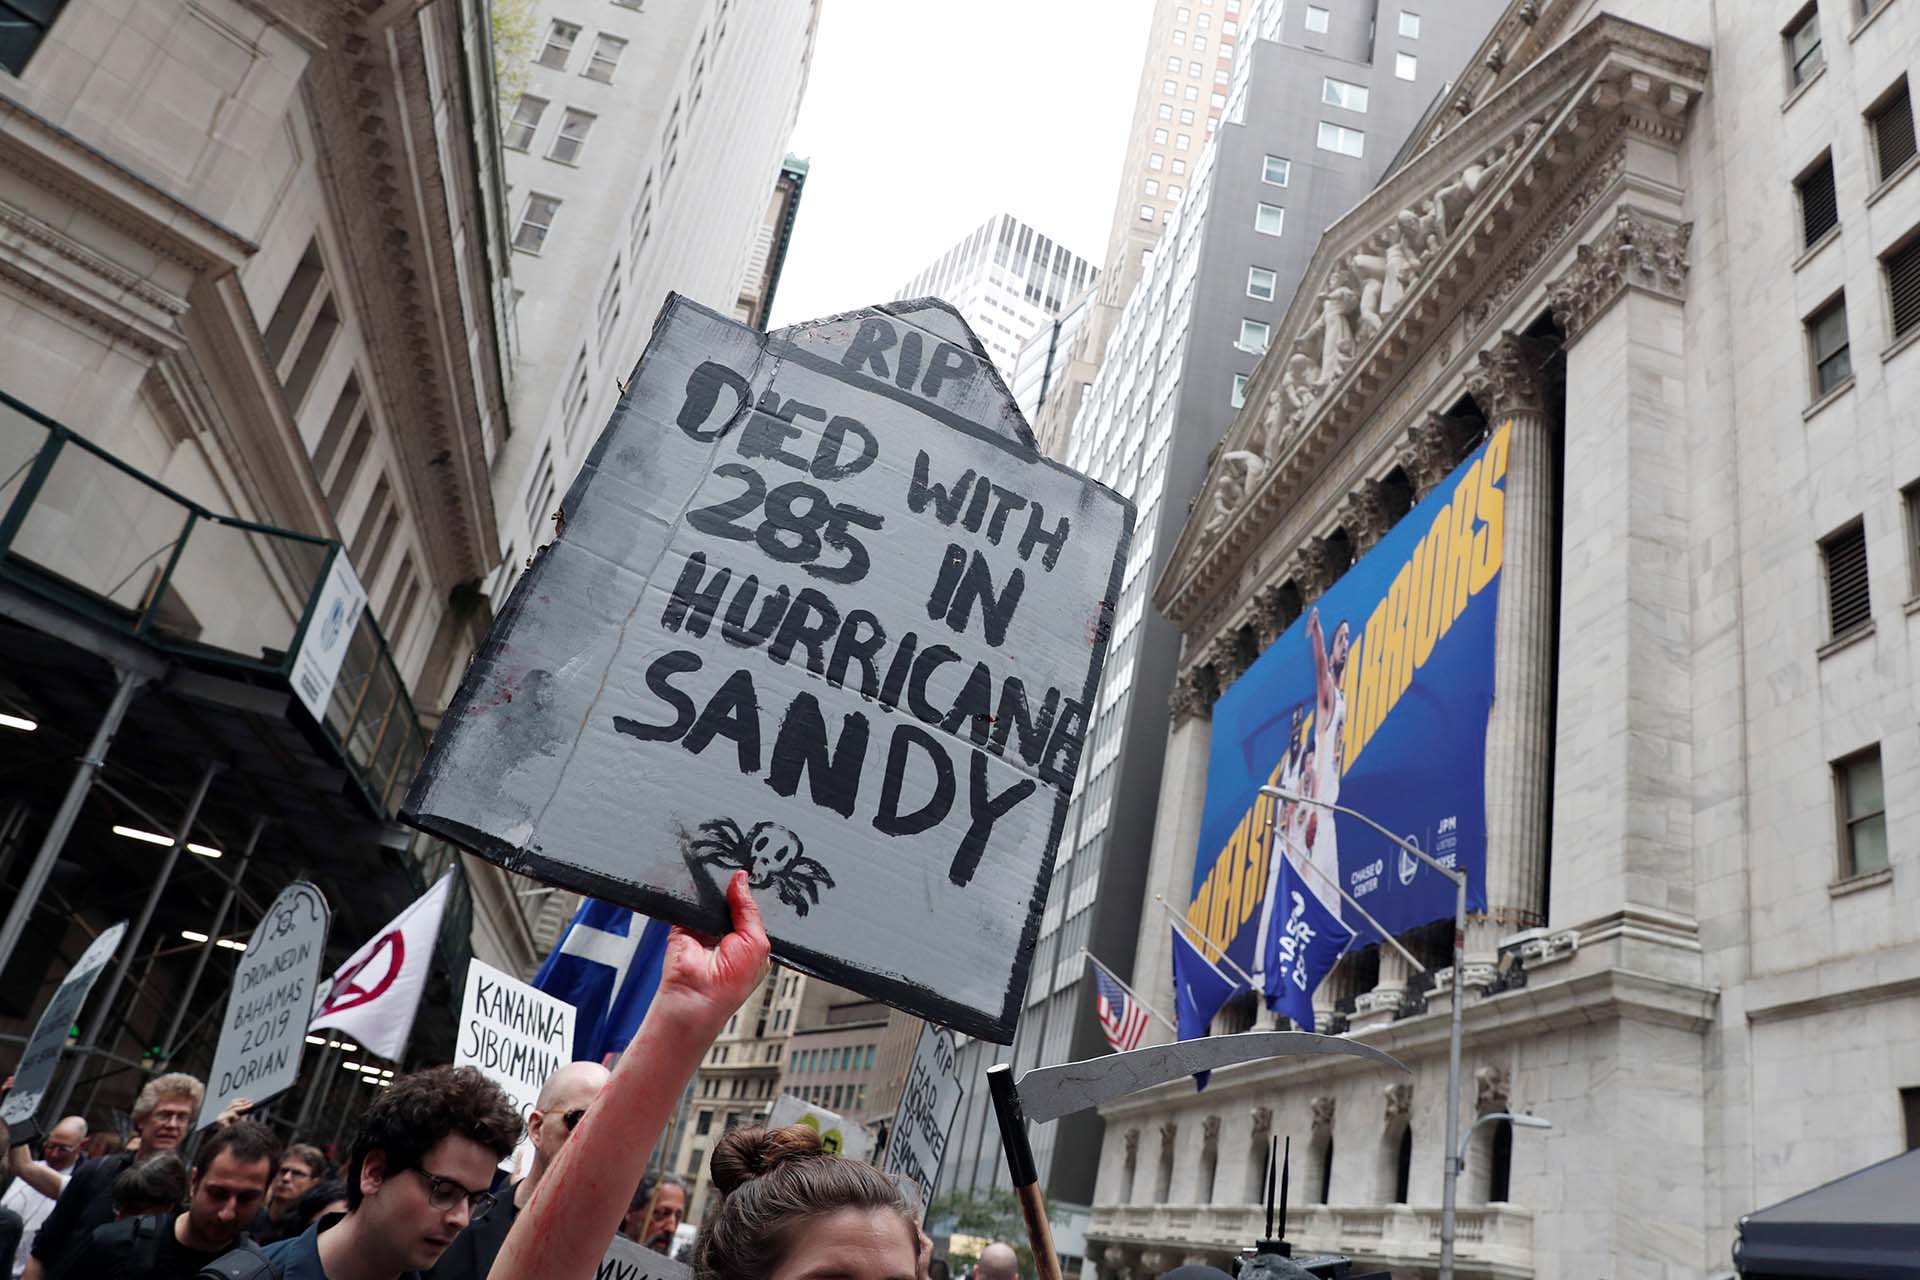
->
[[1175, 426, 1509, 996]]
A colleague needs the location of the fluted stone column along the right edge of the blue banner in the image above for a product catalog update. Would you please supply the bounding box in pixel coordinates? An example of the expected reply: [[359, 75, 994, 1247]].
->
[[1455, 330, 1557, 971]]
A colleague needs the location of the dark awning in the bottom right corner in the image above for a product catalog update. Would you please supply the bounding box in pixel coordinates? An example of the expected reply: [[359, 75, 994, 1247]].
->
[[1734, 1150, 1920, 1280]]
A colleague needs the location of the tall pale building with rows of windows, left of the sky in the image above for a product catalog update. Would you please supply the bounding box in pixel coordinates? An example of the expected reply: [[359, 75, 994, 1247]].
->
[[488, 0, 818, 601]]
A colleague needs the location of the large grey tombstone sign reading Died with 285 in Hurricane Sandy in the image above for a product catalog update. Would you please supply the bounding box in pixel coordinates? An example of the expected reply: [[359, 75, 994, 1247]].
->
[[403, 297, 1133, 1042]]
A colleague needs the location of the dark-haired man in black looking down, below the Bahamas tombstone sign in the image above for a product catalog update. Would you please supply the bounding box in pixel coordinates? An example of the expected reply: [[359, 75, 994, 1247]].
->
[[67, 1121, 280, 1280]]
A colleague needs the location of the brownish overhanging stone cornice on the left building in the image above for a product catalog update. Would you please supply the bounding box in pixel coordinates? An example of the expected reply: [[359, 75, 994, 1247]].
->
[[301, 6, 505, 583]]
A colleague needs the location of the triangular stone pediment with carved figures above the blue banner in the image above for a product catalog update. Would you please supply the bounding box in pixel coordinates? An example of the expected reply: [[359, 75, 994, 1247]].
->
[[1154, 15, 1707, 628]]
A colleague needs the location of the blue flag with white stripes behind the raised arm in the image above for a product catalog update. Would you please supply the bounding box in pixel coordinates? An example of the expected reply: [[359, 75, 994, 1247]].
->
[[534, 898, 668, 1063]]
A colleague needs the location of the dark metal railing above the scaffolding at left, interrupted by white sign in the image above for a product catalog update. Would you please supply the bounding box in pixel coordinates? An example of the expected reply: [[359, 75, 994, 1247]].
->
[[0, 391, 426, 818]]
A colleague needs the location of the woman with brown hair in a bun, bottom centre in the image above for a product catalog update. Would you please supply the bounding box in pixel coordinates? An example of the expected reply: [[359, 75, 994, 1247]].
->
[[693, 1125, 925, 1280]]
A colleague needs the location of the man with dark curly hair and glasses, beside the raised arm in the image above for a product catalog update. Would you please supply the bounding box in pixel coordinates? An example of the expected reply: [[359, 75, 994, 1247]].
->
[[259, 1067, 520, 1280]]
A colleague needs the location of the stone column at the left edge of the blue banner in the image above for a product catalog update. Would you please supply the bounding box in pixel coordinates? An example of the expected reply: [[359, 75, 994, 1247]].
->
[[1133, 666, 1217, 1044]]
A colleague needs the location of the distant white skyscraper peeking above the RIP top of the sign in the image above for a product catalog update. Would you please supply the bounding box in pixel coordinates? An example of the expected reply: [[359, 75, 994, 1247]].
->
[[895, 213, 1098, 380]]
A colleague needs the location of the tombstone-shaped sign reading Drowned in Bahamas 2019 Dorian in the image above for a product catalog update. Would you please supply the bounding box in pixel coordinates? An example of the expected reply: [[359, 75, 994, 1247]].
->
[[194, 881, 332, 1128]]
